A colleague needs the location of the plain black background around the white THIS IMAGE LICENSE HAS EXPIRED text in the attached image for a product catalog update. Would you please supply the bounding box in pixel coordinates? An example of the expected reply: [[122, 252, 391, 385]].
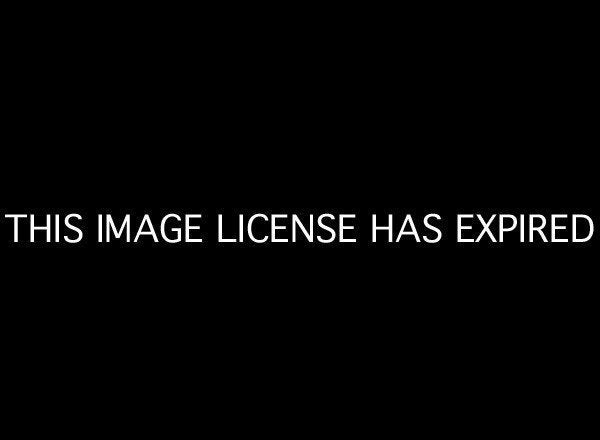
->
[[1, 5, 598, 433]]
